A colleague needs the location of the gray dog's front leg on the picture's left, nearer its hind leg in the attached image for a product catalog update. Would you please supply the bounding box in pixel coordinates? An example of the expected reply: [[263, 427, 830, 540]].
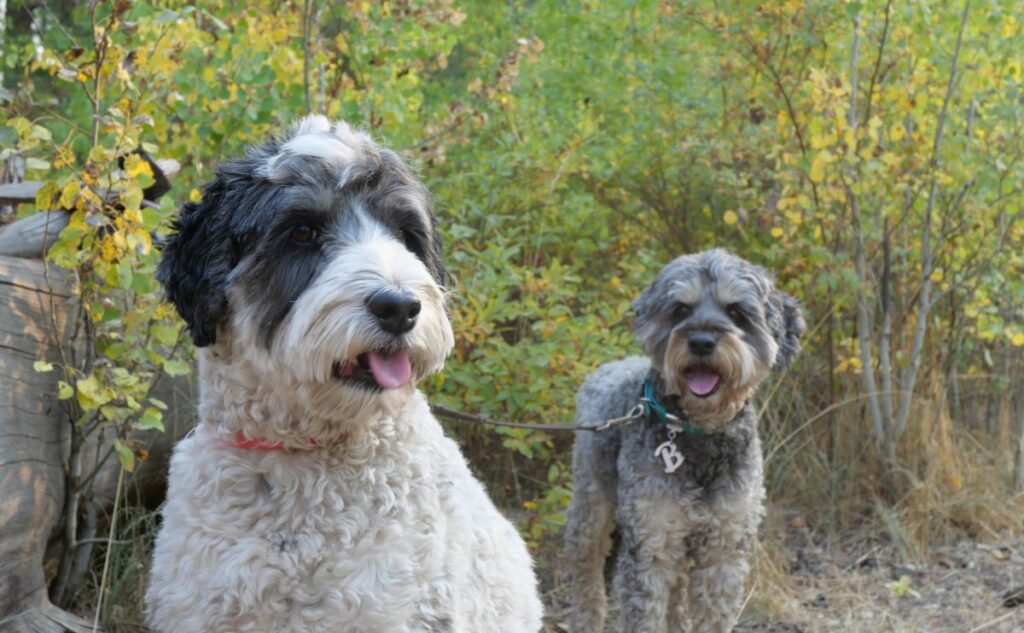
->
[[615, 494, 682, 633]]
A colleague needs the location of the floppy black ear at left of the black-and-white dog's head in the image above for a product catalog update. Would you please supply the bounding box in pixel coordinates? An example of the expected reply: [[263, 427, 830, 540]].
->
[[157, 177, 233, 347]]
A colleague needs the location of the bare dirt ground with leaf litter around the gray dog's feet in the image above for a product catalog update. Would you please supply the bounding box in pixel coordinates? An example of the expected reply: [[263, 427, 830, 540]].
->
[[540, 531, 1024, 633]]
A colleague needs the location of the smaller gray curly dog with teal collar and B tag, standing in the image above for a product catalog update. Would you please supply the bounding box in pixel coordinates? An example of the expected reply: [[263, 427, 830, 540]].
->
[[565, 249, 806, 633]]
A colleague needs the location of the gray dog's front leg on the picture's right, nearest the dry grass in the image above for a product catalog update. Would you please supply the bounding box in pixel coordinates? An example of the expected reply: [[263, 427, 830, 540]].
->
[[689, 524, 755, 633]]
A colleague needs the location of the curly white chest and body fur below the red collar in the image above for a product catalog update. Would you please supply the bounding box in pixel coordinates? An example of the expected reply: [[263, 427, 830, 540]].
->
[[148, 396, 541, 633]]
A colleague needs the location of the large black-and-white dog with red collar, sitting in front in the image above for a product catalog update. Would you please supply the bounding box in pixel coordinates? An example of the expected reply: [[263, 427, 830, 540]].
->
[[146, 117, 542, 633]]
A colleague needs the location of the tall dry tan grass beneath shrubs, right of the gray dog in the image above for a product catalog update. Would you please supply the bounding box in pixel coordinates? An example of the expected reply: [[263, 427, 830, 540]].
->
[[763, 364, 1024, 559]]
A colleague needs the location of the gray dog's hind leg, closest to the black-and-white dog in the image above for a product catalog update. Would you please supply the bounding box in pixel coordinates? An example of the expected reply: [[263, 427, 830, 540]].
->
[[565, 475, 615, 633]]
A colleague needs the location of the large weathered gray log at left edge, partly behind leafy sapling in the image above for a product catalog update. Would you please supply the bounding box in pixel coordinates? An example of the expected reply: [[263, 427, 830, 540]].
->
[[0, 256, 195, 633]]
